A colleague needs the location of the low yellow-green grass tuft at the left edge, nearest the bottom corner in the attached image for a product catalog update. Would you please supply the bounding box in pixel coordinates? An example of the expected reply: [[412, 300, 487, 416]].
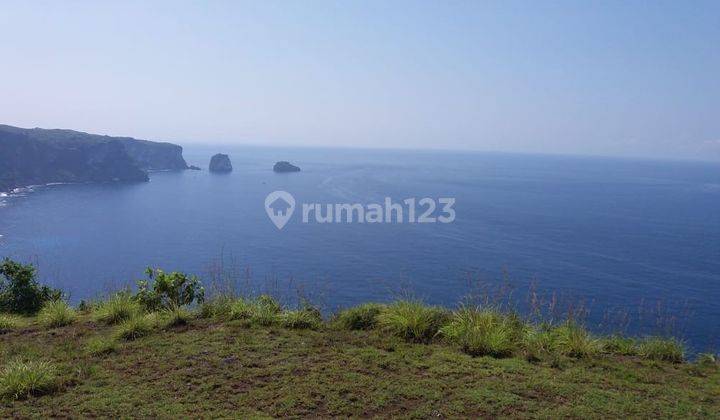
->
[[0, 360, 57, 400]]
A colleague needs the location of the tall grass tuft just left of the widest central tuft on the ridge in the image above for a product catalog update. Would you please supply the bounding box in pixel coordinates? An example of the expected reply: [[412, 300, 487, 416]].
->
[[377, 301, 448, 342]]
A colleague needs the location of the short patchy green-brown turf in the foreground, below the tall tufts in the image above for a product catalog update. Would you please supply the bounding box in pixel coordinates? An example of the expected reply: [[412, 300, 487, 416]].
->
[[0, 312, 720, 418]]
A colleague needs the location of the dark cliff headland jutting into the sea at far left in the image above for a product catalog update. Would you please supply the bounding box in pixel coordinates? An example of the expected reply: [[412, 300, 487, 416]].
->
[[0, 125, 187, 191]]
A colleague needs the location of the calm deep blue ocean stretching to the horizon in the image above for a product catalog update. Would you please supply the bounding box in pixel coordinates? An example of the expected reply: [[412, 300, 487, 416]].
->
[[0, 147, 720, 351]]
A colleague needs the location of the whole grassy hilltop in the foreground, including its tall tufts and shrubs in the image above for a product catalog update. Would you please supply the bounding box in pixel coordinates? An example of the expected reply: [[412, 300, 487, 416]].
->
[[0, 260, 720, 418]]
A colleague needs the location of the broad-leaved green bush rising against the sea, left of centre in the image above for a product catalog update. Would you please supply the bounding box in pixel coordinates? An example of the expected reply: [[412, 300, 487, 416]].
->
[[136, 267, 205, 311]]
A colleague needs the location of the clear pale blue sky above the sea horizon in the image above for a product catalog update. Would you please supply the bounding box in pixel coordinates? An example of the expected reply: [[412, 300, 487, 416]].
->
[[0, 0, 720, 160]]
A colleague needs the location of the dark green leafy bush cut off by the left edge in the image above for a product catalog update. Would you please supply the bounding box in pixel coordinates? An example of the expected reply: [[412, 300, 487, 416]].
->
[[0, 258, 62, 315]]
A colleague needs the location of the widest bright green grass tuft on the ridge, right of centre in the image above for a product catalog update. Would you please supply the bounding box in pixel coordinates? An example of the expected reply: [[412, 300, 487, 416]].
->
[[440, 308, 522, 357]]
